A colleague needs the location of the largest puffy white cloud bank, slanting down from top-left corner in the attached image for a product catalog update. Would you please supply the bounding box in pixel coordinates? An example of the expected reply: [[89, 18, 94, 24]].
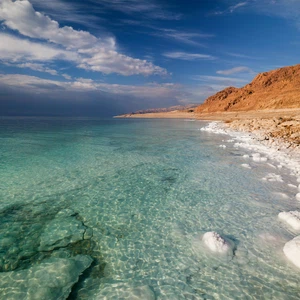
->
[[0, 0, 167, 76]]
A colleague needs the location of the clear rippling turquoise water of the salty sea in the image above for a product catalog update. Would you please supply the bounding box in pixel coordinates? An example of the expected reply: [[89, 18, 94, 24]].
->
[[0, 118, 300, 299]]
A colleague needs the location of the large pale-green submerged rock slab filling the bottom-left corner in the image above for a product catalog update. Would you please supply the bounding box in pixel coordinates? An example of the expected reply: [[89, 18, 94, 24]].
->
[[0, 255, 93, 300]]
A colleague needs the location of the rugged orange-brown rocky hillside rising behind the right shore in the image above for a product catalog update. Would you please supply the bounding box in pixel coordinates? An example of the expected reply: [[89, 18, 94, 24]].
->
[[195, 65, 300, 113]]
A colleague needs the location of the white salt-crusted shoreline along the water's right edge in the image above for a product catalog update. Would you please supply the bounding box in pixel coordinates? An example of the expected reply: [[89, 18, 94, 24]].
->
[[200, 120, 300, 268]]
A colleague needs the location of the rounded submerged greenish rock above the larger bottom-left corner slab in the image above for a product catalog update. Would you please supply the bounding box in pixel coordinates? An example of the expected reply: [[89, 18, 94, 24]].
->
[[39, 209, 86, 251]]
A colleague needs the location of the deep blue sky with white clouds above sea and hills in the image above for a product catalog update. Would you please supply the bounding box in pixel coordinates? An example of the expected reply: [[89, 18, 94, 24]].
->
[[0, 0, 300, 117]]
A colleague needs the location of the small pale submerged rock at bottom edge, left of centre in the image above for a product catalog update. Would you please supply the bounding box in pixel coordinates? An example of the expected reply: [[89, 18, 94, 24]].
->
[[95, 283, 155, 300]]
